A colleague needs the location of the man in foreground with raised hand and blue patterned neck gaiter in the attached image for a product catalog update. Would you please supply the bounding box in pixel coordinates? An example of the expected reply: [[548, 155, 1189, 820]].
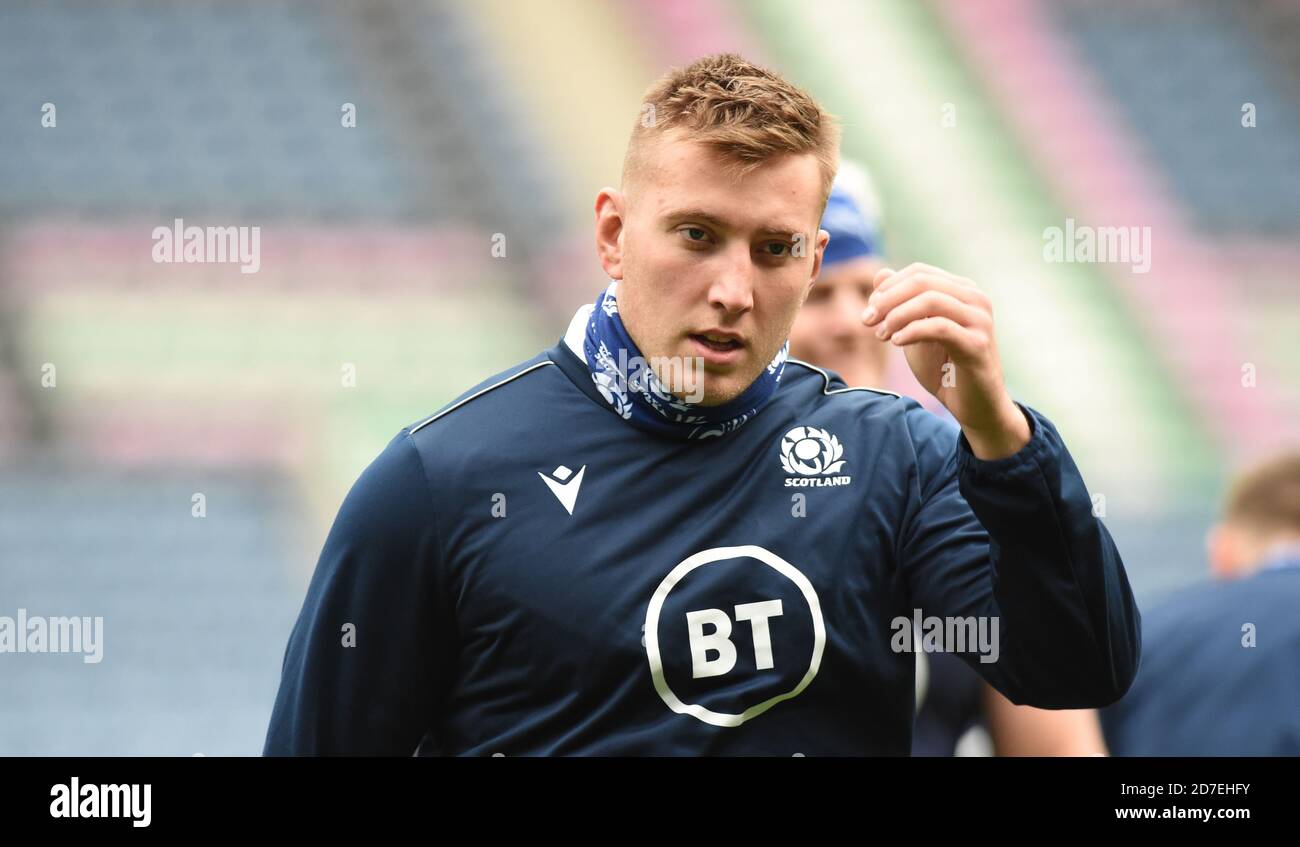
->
[[265, 55, 1139, 756]]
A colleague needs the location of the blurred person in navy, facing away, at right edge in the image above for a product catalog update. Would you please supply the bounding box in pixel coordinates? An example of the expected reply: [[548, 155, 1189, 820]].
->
[[1101, 452, 1300, 756]]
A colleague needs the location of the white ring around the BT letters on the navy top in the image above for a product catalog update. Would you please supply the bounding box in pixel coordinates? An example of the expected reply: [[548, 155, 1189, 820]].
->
[[645, 544, 826, 726]]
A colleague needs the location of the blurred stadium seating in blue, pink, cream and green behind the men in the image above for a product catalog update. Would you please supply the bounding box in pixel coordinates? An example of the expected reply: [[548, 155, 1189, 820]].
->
[[0, 0, 1300, 756]]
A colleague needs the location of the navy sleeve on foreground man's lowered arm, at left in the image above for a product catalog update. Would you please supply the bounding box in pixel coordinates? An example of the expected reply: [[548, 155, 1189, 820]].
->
[[263, 431, 455, 756]]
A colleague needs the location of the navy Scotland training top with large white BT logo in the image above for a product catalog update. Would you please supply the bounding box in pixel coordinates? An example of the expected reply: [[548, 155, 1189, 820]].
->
[[264, 324, 1140, 756]]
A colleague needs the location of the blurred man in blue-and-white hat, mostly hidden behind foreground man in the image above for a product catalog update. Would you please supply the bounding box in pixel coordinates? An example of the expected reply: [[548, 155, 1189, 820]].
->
[[790, 170, 1106, 756]]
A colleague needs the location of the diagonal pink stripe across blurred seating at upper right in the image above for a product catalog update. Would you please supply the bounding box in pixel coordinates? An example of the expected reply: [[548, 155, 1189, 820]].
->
[[937, 0, 1296, 456]]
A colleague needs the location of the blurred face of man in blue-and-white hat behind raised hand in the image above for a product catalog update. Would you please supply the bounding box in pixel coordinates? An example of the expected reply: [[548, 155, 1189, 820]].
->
[[790, 256, 891, 386]]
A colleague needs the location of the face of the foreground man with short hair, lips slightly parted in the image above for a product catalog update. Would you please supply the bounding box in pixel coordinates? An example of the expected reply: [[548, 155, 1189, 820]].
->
[[597, 131, 827, 405]]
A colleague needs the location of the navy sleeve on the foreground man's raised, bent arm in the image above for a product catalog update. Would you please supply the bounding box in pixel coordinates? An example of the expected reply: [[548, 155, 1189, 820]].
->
[[898, 405, 1141, 708]]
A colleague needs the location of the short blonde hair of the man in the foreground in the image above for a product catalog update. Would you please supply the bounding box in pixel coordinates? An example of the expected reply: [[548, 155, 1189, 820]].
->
[[623, 53, 840, 208]]
